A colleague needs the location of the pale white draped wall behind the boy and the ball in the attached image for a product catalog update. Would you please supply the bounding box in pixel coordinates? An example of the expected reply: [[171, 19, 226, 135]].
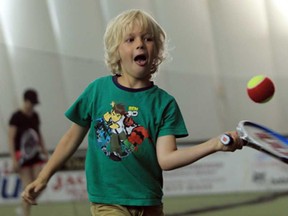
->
[[0, 0, 288, 153]]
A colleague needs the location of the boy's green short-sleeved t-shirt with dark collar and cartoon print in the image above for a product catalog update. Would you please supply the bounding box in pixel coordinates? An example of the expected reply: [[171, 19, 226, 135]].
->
[[65, 76, 188, 206]]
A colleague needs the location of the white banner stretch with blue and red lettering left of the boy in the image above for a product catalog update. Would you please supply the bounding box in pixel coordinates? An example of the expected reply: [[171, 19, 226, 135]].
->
[[0, 158, 87, 204]]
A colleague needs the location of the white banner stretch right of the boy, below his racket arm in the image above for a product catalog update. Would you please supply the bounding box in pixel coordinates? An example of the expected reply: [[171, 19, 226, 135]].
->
[[164, 147, 288, 196]]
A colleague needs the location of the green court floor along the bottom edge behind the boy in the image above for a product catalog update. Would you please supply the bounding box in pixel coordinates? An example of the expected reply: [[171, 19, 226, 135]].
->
[[0, 191, 288, 216]]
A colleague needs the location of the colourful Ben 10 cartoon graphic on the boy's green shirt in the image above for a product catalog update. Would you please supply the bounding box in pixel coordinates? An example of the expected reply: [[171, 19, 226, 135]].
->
[[94, 102, 150, 161]]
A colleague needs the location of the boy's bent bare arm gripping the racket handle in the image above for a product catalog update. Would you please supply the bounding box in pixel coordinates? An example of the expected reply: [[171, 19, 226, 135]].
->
[[156, 132, 243, 170]]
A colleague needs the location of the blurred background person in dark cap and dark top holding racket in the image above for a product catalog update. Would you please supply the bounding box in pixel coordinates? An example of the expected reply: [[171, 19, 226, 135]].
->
[[8, 89, 48, 216]]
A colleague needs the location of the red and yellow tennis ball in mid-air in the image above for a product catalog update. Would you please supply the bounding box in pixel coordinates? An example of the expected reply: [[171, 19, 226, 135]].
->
[[247, 75, 275, 103]]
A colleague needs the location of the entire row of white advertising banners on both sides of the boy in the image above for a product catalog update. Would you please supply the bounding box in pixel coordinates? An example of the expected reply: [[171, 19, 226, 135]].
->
[[0, 147, 288, 204]]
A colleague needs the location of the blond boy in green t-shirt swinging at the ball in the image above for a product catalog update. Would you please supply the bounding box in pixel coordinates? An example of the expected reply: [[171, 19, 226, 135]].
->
[[22, 10, 242, 216]]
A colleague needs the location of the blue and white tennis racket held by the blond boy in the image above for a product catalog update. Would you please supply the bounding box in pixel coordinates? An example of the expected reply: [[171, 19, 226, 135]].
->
[[220, 121, 288, 164]]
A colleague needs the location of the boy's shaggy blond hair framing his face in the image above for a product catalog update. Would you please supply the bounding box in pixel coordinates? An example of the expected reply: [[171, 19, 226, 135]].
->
[[104, 9, 166, 74]]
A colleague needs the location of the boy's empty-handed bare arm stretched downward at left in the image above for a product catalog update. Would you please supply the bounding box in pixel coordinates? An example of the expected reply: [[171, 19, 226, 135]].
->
[[22, 123, 89, 205]]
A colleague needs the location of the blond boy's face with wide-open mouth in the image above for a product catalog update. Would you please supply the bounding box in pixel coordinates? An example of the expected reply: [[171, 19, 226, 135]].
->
[[118, 24, 156, 79]]
